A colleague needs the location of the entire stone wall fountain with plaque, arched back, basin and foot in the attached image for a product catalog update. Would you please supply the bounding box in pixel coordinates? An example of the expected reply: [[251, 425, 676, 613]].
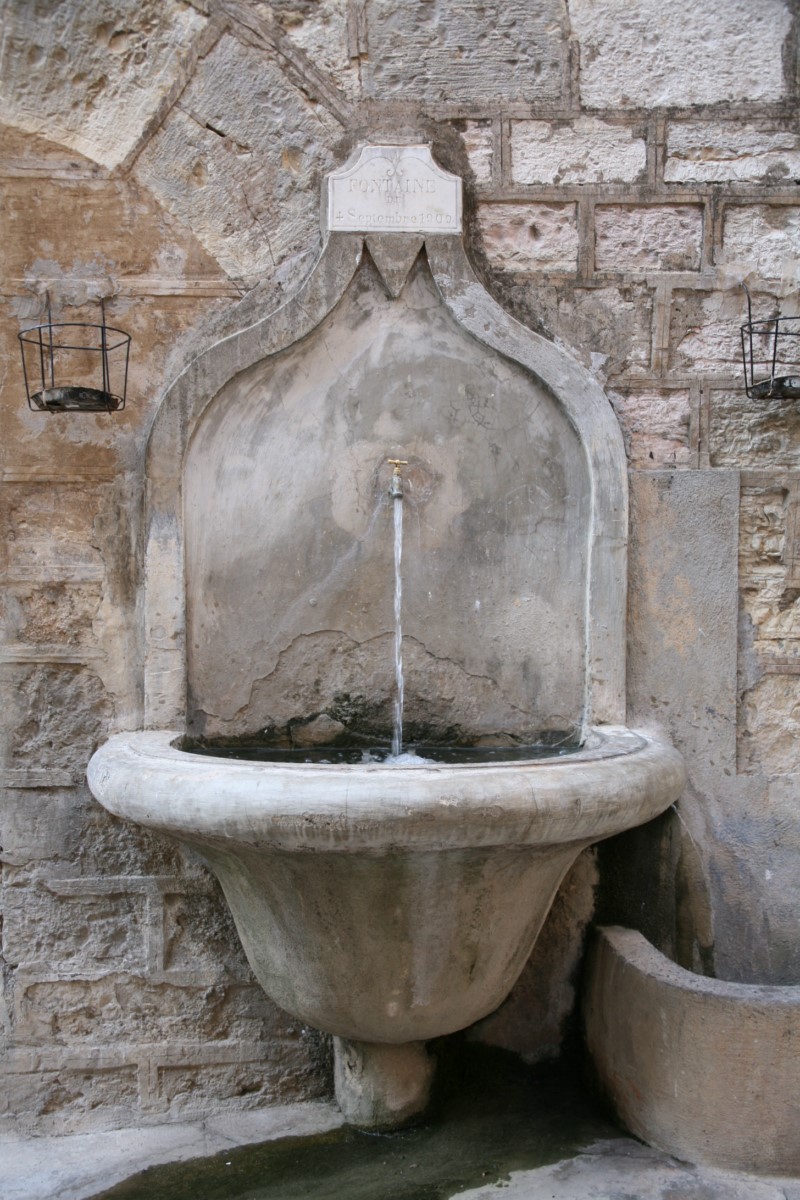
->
[[89, 145, 684, 1128]]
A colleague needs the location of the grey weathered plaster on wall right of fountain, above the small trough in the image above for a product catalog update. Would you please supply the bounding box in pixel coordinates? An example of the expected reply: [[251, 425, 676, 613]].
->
[[628, 469, 799, 983]]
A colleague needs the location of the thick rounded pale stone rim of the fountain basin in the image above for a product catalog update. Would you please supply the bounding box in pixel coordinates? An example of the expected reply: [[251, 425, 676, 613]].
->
[[88, 726, 685, 851]]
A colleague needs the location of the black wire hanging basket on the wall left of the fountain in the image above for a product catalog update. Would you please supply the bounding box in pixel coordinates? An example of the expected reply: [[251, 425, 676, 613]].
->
[[18, 298, 131, 413]]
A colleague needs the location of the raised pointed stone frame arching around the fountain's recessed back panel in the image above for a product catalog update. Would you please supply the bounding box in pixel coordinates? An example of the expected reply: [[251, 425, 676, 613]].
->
[[144, 154, 627, 728]]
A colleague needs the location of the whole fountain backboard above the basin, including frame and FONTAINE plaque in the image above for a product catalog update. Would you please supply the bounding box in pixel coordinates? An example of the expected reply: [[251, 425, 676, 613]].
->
[[144, 145, 627, 744]]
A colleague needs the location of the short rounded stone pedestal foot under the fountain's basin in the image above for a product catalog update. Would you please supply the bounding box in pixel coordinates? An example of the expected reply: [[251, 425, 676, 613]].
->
[[333, 1037, 434, 1132]]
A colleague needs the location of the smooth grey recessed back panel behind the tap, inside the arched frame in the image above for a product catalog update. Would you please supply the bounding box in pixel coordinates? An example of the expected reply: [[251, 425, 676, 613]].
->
[[185, 254, 591, 742]]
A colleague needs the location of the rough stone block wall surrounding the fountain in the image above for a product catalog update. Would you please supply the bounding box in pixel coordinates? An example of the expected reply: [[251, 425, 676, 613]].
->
[[0, 0, 800, 1130]]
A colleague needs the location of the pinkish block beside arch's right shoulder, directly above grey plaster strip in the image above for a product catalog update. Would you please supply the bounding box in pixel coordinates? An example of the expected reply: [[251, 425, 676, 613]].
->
[[614, 390, 691, 470]]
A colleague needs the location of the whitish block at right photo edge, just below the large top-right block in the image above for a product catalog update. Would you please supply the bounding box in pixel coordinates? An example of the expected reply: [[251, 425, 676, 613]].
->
[[664, 120, 800, 184]]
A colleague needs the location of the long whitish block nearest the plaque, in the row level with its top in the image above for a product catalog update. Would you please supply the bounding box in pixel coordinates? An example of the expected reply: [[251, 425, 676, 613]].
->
[[511, 116, 646, 185]]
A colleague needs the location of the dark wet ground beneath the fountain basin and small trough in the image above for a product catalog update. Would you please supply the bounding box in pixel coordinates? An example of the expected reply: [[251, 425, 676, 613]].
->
[[86, 1046, 619, 1200]]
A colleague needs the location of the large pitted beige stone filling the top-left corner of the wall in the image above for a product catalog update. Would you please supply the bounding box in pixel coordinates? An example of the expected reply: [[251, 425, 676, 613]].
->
[[0, 0, 206, 167]]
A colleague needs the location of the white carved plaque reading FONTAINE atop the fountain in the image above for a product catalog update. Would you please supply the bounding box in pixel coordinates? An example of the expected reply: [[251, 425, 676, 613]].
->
[[327, 145, 461, 234]]
